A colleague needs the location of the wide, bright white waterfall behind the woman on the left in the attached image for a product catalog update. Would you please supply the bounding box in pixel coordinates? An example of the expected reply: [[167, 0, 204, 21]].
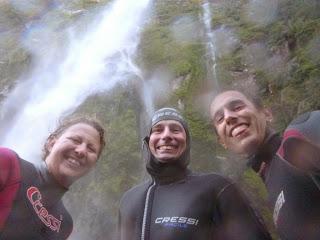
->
[[0, 0, 149, 161]]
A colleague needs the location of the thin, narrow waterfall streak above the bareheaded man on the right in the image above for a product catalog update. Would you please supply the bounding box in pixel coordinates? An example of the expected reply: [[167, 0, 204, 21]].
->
[[202, 1, 219, 91]]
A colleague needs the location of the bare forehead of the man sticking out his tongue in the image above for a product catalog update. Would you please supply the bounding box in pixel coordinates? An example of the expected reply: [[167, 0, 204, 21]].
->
[[210, 91, 253, 114]]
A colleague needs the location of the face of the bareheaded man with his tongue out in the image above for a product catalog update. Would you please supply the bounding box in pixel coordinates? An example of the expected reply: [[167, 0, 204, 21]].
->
[[210, 91, 272, 155]]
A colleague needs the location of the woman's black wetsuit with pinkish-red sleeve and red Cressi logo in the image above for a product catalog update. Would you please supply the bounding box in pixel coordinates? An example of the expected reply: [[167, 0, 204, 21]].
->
[[0, 148, 73, 240]]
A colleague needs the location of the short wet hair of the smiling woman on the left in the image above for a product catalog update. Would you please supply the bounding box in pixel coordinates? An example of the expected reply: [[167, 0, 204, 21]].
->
[[42, 117, 106, 160]]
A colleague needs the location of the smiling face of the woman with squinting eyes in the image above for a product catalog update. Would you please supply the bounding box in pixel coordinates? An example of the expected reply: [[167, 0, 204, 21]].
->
[[45, 123, 101, 187]]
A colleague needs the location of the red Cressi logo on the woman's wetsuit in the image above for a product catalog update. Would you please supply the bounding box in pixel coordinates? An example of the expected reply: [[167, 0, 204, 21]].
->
[[27, 187, 61, 232]]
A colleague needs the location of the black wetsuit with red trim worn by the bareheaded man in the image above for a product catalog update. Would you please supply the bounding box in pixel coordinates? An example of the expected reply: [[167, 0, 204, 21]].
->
[[249, 111, 320, 240]]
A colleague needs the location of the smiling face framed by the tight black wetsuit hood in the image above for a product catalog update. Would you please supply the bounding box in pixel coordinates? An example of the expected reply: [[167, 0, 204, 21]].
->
[[149, 120, 187, 163]]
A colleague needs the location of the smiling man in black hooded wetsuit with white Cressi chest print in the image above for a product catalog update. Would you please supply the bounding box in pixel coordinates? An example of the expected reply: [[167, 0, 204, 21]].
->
[[117, 108, 271, 240]]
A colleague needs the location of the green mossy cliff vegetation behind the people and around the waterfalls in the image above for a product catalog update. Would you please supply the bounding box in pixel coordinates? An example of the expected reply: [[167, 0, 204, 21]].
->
[[0, 0, 320, 239]]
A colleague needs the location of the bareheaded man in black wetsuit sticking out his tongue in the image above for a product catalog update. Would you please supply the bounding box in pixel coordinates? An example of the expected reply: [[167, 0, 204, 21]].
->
[[210, 89, 320, 240]]
